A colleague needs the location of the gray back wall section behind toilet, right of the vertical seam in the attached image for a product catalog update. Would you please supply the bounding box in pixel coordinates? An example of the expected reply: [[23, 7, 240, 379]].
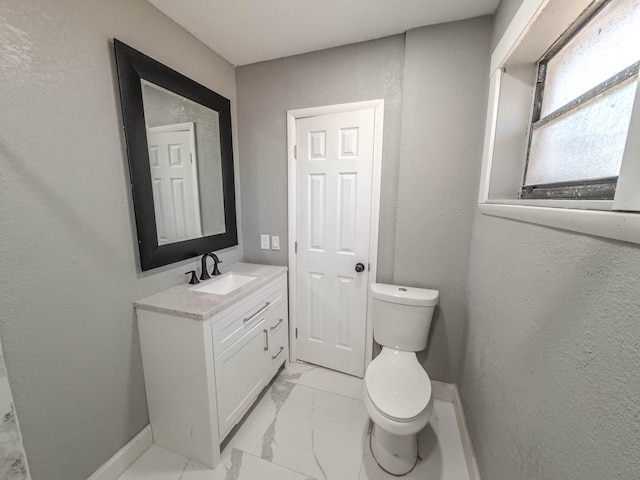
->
[[393, 17, 491, 382]]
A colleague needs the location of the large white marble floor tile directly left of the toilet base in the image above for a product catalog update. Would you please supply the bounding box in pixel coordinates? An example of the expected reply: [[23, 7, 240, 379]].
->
[[253, 385, 369, 480]]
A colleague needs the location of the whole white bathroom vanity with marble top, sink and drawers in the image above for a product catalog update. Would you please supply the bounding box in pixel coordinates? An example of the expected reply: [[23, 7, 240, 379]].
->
[[135, 263, 289, 468]]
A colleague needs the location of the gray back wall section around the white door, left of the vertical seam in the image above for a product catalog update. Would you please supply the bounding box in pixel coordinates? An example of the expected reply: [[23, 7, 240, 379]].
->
[[236, 35, 404, 281]]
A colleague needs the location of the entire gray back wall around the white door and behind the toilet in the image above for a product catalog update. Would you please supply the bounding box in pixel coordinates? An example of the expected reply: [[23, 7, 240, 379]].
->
[[236, 17, 491, 382]]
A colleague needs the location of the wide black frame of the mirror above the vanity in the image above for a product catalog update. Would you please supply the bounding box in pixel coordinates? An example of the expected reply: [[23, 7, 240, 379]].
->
[[113, 39, 238, 271]]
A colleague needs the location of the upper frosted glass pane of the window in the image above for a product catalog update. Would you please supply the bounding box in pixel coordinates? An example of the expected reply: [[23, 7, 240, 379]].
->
[[541, 0, 640, 117]]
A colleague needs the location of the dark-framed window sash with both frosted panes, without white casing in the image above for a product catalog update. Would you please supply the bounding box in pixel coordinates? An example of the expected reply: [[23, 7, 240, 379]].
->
[[519, 0, 640, 200]]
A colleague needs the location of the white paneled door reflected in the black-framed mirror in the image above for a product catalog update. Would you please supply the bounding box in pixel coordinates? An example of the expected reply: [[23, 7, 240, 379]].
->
[[147, 123, 202, 245]]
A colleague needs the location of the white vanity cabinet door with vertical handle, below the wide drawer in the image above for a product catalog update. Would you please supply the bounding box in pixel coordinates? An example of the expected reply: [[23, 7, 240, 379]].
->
[[215, 320, 268, 440]]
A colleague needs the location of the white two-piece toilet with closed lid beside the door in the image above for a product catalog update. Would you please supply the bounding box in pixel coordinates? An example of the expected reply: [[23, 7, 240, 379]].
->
[[363, 283, 439, 476]]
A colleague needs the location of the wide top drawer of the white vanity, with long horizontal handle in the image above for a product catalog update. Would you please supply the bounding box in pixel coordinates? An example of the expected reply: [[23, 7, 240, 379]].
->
[[211, 282, 286, 357]]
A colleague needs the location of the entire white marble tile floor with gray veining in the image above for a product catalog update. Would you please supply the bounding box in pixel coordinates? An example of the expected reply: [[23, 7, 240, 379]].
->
[[119, 363, 469, 480]]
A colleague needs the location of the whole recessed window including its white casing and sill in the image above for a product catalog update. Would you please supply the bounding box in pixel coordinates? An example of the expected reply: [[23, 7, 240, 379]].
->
[[479, 0, 640, 243]]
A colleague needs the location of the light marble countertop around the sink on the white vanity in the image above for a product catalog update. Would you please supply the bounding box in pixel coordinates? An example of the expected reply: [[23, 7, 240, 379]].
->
[[134, 263, 287, 320]]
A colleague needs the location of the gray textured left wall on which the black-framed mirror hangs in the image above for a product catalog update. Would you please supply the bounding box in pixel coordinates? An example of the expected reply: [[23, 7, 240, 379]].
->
[[0, 0, 242, 480]]
